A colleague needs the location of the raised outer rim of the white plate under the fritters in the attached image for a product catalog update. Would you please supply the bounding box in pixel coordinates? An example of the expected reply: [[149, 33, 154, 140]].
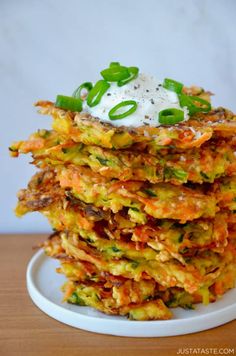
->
[[26, 249, 236, 337]]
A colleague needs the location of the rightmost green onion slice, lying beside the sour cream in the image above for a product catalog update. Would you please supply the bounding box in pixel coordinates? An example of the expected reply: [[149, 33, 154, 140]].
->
[[179, 94, 211, 115]]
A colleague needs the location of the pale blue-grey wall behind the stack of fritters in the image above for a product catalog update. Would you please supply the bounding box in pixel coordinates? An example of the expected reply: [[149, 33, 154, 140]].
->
[[0, 0, 236, 232]]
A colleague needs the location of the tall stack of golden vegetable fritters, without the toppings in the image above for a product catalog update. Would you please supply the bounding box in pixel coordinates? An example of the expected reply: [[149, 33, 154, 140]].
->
[[10, 96, 236, 320]]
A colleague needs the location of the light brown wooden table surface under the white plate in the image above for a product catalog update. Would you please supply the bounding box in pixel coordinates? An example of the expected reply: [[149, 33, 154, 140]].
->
[[0, 235, 236, 356]]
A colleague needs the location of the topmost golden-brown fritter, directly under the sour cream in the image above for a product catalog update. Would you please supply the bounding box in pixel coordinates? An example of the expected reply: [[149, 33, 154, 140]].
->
[[35, 101, 236, 149]]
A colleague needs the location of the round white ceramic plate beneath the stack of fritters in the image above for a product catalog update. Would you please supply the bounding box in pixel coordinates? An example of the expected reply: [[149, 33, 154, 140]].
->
[[27, 250, 236, 337]]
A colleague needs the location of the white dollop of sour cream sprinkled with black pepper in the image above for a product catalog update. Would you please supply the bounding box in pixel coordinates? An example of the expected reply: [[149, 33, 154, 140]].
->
[[83, 74, 189, 127]]
